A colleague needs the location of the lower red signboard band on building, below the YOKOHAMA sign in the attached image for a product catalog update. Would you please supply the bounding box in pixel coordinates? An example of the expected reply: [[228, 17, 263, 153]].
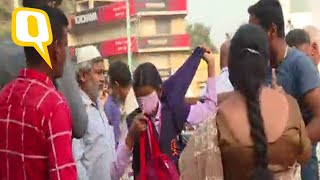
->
[[71, 34, 190, 57]]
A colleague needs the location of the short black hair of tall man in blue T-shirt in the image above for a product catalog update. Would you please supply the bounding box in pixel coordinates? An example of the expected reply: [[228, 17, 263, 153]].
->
[[248, 0, 285, 38]]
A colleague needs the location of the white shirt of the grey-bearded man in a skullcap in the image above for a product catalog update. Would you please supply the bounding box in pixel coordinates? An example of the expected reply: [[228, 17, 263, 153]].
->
[[74, 91, 116, 180]]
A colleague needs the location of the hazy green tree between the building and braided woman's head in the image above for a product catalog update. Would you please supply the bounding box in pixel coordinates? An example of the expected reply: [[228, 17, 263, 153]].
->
[[187, 23, 218, 52]]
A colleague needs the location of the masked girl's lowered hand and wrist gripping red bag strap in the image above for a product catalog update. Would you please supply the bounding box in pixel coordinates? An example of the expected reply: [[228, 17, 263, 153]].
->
[[126, 114, 148, 149]]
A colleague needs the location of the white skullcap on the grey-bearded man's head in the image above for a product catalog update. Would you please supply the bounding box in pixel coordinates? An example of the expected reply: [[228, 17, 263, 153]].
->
[[75, 45, 101, 64]]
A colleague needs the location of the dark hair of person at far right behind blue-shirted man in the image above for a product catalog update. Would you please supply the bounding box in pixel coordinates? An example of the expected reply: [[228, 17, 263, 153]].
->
[[286, 29, 310, 47]]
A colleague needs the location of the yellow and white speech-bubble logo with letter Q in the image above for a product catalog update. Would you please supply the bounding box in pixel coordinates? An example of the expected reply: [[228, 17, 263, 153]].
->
[[11, 7, 52, 68]]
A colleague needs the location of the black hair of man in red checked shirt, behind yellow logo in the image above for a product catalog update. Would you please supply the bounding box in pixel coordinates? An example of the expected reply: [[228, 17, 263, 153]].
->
[[24, 4, 69, 66]]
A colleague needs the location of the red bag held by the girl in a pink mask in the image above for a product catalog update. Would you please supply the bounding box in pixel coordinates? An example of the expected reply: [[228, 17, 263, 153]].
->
[[137, 120, 179, 180]]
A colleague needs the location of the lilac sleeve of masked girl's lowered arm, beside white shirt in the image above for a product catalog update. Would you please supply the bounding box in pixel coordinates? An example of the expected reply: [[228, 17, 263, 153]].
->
[[110, 141, 132, 180]]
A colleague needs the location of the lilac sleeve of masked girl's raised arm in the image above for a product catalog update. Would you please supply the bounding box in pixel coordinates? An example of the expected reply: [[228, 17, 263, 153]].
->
[[187, 78, 217, 125]]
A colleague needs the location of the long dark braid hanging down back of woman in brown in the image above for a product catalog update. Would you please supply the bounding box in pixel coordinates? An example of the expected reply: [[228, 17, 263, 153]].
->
[[232, 49, 272, 180]]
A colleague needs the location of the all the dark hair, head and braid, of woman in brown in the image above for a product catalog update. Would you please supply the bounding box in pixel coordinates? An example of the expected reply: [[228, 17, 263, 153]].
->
[[229, 24, 273, 180]]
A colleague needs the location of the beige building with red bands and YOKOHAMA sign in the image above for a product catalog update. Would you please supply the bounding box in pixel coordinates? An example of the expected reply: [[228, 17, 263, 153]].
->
[[69, 0, 208, 96]]
